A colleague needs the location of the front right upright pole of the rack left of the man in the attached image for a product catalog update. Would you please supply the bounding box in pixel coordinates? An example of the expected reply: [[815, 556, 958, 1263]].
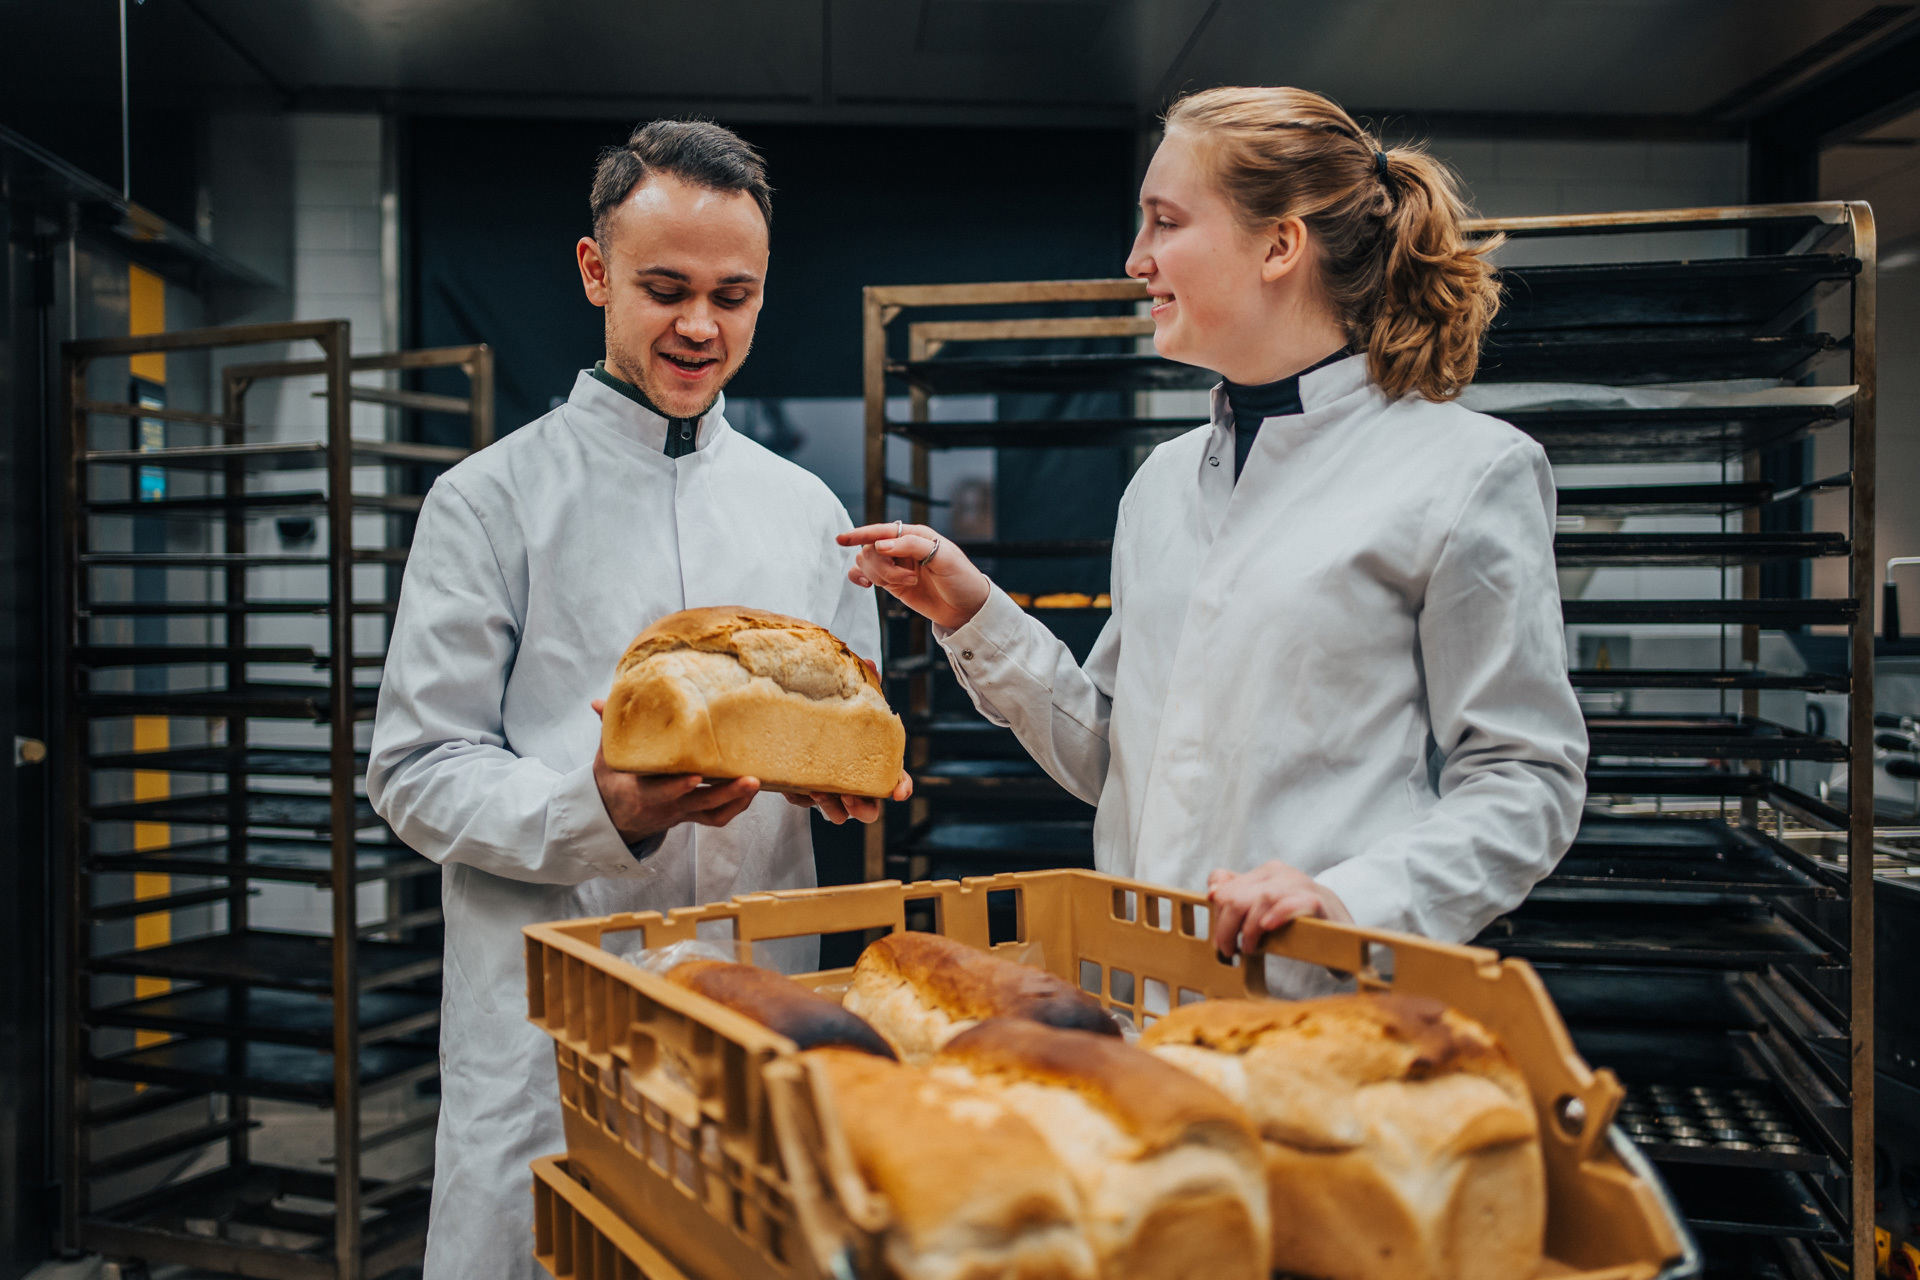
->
[[321, 320, 361, 1280]]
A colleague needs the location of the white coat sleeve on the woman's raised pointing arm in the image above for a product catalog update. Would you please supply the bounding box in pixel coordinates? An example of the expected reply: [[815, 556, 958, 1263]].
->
[[933, 507, 1127, 804]]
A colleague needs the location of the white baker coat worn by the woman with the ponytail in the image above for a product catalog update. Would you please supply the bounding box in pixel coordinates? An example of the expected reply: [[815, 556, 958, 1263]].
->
[[935, 357, 1586, 959]]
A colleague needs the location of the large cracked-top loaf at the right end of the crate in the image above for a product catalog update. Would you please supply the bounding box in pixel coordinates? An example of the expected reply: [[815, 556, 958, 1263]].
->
[[1140, 994, 1546, 1280]]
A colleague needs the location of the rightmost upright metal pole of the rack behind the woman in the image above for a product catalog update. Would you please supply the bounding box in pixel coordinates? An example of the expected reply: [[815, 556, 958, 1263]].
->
[[1847, 201, 1880, 1276]]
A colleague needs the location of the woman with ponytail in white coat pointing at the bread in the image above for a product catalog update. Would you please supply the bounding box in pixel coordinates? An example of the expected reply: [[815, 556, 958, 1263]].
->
[[839, 88, 1586, 974]]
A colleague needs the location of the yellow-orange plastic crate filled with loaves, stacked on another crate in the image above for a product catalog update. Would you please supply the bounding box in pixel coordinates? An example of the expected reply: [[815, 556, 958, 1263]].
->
[[524, 871, 1699, 1280]]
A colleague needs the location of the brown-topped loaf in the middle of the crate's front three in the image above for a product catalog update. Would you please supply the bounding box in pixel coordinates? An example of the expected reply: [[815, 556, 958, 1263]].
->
[[933, 1017, 1269, 1280]]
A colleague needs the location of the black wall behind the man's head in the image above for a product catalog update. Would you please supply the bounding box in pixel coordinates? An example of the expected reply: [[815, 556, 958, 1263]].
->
[[403, 119, 1135, 430]]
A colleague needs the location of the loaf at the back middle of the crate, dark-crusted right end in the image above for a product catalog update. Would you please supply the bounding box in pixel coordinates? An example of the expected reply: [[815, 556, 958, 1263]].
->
[[845, 933, 1119, 1063]]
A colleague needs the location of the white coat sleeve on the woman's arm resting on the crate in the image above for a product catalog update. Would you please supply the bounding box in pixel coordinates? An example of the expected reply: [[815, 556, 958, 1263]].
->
[[1319, 441, 1588, 942]]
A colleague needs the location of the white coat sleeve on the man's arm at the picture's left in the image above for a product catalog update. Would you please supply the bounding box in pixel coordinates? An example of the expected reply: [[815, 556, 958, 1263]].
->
[[367, 480, 651, 885]]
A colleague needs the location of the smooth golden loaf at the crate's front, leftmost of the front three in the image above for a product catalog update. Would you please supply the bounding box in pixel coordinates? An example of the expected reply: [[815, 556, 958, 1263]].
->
[[806, 1050, 1094, 1280]]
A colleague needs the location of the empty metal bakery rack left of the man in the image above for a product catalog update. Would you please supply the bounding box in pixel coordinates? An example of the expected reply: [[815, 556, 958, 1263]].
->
[[56, 320, 493, 1280]]
